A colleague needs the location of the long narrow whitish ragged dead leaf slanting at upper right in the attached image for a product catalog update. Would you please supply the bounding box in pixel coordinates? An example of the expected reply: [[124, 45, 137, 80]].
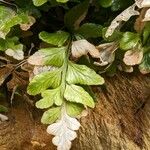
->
[[105, 4, 140, 38]]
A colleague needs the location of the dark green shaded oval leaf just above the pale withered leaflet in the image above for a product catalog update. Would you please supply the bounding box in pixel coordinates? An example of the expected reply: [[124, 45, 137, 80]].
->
[[77, 23, 103, 38]]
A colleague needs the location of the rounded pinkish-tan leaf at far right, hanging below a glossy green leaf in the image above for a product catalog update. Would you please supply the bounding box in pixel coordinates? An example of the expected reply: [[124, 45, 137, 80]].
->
[[123, 49, 143, 66]]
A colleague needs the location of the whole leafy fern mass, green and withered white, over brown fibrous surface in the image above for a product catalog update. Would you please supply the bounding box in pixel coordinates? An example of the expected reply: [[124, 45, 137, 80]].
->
[[0, 0, 150, 150]]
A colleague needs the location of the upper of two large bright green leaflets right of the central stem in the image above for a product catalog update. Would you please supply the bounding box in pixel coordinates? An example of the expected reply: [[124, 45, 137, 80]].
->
[[66, 62, 104, 85]]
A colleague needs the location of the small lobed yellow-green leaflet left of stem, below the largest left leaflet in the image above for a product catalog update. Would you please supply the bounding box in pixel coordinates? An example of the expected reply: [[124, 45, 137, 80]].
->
[[36, 87, 63, 109]]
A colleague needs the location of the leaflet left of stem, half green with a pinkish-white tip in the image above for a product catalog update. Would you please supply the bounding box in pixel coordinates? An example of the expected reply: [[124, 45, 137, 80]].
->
[[28, 47, 66, 67]]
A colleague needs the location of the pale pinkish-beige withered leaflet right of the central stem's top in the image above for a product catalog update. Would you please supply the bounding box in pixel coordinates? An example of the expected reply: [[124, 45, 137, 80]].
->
[[71, 39, 99, 58]]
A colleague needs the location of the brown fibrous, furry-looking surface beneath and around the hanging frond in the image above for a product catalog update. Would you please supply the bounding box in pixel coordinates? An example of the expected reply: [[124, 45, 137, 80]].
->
[[0, 73, 150, 150]]
